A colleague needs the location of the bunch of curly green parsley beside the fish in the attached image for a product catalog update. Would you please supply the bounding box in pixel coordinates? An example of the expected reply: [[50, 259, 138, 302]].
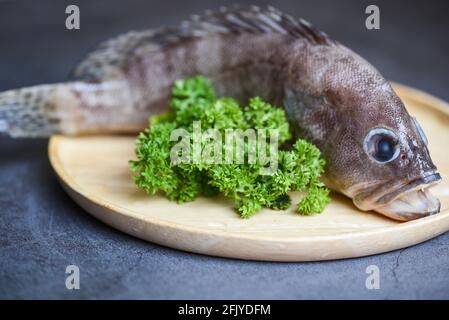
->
[[129, 76, 330, 218]]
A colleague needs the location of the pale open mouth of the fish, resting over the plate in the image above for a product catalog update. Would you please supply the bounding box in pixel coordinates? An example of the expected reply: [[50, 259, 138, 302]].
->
[[354, 172, 441, 221]]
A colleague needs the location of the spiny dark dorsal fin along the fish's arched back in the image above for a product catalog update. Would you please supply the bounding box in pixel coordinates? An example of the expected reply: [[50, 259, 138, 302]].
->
[[73, 5, 336, 82]]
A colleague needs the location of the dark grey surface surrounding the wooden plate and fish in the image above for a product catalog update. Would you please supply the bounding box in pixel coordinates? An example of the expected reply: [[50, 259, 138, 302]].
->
[[0, 0, 449, 299]]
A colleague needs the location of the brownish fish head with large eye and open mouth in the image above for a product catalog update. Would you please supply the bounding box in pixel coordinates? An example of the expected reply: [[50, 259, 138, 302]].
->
[[326, 82, 441, 221]]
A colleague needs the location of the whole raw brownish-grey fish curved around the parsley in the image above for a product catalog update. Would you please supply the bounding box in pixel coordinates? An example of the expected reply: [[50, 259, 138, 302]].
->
[[0, 6, 441, 221]]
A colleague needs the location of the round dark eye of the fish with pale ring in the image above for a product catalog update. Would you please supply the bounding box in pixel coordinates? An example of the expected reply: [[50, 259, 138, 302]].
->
[[364, 128, 399, 163]]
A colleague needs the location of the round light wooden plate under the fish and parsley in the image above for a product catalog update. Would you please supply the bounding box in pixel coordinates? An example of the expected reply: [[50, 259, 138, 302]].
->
[[49, 85, 449, 261]]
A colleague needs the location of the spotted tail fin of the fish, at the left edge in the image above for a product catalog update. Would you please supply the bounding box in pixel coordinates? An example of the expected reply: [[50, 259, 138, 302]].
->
[[0, 84, 66, 137]]
